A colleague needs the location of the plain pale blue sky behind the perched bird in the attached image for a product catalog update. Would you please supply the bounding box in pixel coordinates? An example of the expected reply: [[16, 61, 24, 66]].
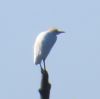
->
[[0, 0, 100, 99]]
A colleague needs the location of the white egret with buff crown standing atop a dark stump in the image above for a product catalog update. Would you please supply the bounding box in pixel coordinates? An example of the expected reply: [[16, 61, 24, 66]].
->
[[34, 28, 64, 69]]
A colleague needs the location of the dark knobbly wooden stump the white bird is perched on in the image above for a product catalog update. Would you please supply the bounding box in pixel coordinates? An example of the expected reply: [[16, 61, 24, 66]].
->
[[39, 68, 51, 99]]
